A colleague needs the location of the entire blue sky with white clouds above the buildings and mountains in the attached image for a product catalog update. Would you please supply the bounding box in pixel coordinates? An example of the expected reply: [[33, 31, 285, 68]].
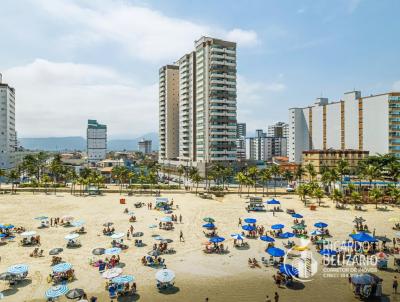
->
[[0, 0, 400, 138]]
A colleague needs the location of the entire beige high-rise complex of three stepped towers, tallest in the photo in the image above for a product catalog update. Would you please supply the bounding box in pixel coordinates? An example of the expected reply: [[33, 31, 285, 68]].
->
[[159, 37, 236, 164]]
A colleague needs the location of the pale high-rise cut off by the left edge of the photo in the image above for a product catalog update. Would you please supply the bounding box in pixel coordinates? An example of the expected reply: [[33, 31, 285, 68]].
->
[[0, 74, 17, 169]]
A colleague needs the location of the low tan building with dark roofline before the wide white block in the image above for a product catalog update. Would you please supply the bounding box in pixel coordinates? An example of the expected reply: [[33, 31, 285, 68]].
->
[[303, 149, 369, 174]]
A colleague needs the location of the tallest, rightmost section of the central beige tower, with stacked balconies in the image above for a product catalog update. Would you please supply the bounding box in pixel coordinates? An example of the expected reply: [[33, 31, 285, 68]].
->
[[195, 37, 236, 163]]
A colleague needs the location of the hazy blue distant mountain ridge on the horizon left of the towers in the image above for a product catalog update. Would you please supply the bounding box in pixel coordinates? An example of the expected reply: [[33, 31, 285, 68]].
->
[[19, 132, 158, 151]]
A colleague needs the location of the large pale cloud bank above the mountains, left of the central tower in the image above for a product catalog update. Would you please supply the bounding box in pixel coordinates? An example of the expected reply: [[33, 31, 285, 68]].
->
[[3, 59, 158, 137]]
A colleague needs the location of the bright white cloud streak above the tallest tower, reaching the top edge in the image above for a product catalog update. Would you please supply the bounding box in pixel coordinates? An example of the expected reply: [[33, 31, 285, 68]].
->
[[35, 0, 258, 62]]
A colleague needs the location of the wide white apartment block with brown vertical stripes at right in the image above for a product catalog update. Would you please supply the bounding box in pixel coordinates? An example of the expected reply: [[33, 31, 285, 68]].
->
[[289, 91, 400, 163]]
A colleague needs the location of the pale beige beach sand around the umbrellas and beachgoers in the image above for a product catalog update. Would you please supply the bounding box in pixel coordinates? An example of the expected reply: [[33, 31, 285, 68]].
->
[[0, 193, 400, 302]]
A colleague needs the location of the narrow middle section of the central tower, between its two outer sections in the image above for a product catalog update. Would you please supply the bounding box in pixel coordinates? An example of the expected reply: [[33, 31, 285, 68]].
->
[[177, 51, 196, 161]]
